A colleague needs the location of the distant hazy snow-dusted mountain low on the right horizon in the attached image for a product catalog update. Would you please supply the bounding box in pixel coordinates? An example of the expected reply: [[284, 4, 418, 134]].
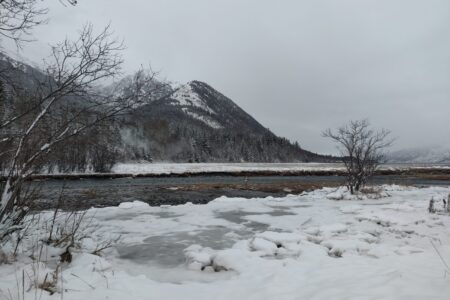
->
[[388, 146, 450, 164]]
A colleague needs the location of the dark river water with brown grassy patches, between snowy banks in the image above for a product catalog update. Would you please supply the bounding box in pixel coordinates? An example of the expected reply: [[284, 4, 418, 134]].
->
[[32, 175, 450, 209]]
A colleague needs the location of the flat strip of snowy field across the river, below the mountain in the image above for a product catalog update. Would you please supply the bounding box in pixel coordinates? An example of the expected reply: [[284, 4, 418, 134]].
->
[[112, 163, 449, 174]]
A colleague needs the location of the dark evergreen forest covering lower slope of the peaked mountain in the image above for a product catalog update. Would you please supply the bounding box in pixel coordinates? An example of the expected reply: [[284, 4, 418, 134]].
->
[[121, 104, 335, 163]]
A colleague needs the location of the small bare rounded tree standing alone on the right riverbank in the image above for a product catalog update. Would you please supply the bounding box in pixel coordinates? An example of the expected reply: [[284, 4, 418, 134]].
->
[[323, 120, 393, 194]]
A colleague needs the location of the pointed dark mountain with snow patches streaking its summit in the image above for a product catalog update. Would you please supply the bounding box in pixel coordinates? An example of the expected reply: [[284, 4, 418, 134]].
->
[[120, 81, 331, 162]]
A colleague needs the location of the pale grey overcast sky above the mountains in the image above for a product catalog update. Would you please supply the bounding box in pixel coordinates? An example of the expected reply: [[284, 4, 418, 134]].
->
[[3, 0, 450, 153]]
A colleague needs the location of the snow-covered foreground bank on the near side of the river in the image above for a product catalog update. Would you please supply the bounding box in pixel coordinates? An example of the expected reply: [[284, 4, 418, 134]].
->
[[0, 186, 450, 300]]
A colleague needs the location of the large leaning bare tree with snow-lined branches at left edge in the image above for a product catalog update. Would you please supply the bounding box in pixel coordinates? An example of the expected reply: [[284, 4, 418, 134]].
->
[[0, 25, 162, 241]]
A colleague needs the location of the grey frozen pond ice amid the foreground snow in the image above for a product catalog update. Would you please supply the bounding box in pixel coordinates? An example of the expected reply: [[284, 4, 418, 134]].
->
[[111, 207, 295, 283]]
